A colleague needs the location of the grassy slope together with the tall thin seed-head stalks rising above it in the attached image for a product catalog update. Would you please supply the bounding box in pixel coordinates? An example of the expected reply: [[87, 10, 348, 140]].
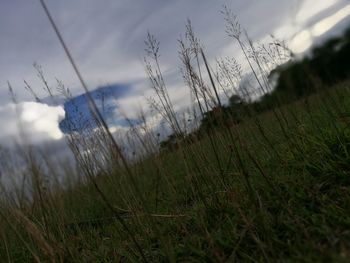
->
[[0, 4, 350, 262]]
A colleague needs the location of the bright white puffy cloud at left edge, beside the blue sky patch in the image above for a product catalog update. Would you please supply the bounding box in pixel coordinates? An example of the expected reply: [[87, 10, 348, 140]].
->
[[0, 102, 65, 144]]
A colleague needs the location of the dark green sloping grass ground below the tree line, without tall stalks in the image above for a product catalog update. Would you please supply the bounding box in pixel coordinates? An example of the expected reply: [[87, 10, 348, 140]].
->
[[0, 82, 350, 262]]
